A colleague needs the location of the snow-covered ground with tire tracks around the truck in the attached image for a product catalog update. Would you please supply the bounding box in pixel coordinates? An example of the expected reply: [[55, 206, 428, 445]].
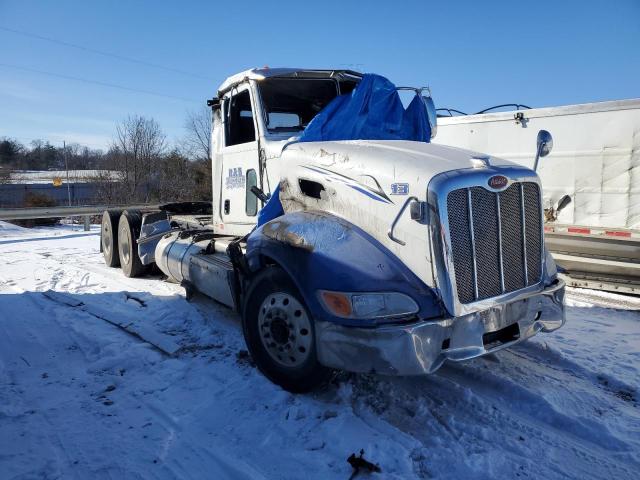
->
[[0, 222, 640, 480]]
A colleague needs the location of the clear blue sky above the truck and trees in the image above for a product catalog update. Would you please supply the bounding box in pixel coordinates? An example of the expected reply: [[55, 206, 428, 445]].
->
[[0, 0, 640, 148]]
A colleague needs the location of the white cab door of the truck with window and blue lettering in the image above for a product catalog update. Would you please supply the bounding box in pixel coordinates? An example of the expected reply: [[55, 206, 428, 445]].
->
[[220, 85, 259, 235]]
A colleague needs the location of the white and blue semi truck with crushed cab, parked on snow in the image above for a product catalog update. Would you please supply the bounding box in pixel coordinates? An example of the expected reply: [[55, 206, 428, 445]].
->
[[101, 68, 565, 391]]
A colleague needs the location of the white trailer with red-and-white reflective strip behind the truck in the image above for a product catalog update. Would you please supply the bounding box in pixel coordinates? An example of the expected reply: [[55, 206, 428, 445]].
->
[[435, 99, 640, 293]]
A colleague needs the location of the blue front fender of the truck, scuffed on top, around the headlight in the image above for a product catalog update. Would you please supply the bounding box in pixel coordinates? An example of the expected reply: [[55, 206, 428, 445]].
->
[[246, 211, 445, 326]]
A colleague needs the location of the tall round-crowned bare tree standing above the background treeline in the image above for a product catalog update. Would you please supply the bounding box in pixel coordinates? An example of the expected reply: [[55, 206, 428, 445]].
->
[[109, 115, 166, 202]]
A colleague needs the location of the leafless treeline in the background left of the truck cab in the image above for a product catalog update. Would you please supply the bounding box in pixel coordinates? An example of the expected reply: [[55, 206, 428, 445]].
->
[[0, 109, 211, 204]]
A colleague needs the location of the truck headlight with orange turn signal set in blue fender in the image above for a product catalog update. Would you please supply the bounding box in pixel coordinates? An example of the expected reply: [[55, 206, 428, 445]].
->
[[319, 290, 418, 319]]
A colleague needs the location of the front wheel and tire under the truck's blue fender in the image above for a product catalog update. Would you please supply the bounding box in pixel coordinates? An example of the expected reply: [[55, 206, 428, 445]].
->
[[242, 267, 332, 393]]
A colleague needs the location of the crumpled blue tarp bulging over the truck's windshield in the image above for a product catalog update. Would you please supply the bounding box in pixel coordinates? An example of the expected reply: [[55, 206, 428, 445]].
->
[[298, 74, 431, 143]]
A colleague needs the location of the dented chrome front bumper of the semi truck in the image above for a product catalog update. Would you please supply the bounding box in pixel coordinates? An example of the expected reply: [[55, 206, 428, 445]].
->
[[316, 280, 565, 375]]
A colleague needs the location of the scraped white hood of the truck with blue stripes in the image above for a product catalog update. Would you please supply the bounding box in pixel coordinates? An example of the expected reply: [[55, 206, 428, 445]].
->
[[276, 140, 536, 285]]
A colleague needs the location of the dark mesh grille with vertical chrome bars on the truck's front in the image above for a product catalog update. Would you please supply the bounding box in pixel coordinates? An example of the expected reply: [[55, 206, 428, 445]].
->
[[447, 182, 543, 304]]
